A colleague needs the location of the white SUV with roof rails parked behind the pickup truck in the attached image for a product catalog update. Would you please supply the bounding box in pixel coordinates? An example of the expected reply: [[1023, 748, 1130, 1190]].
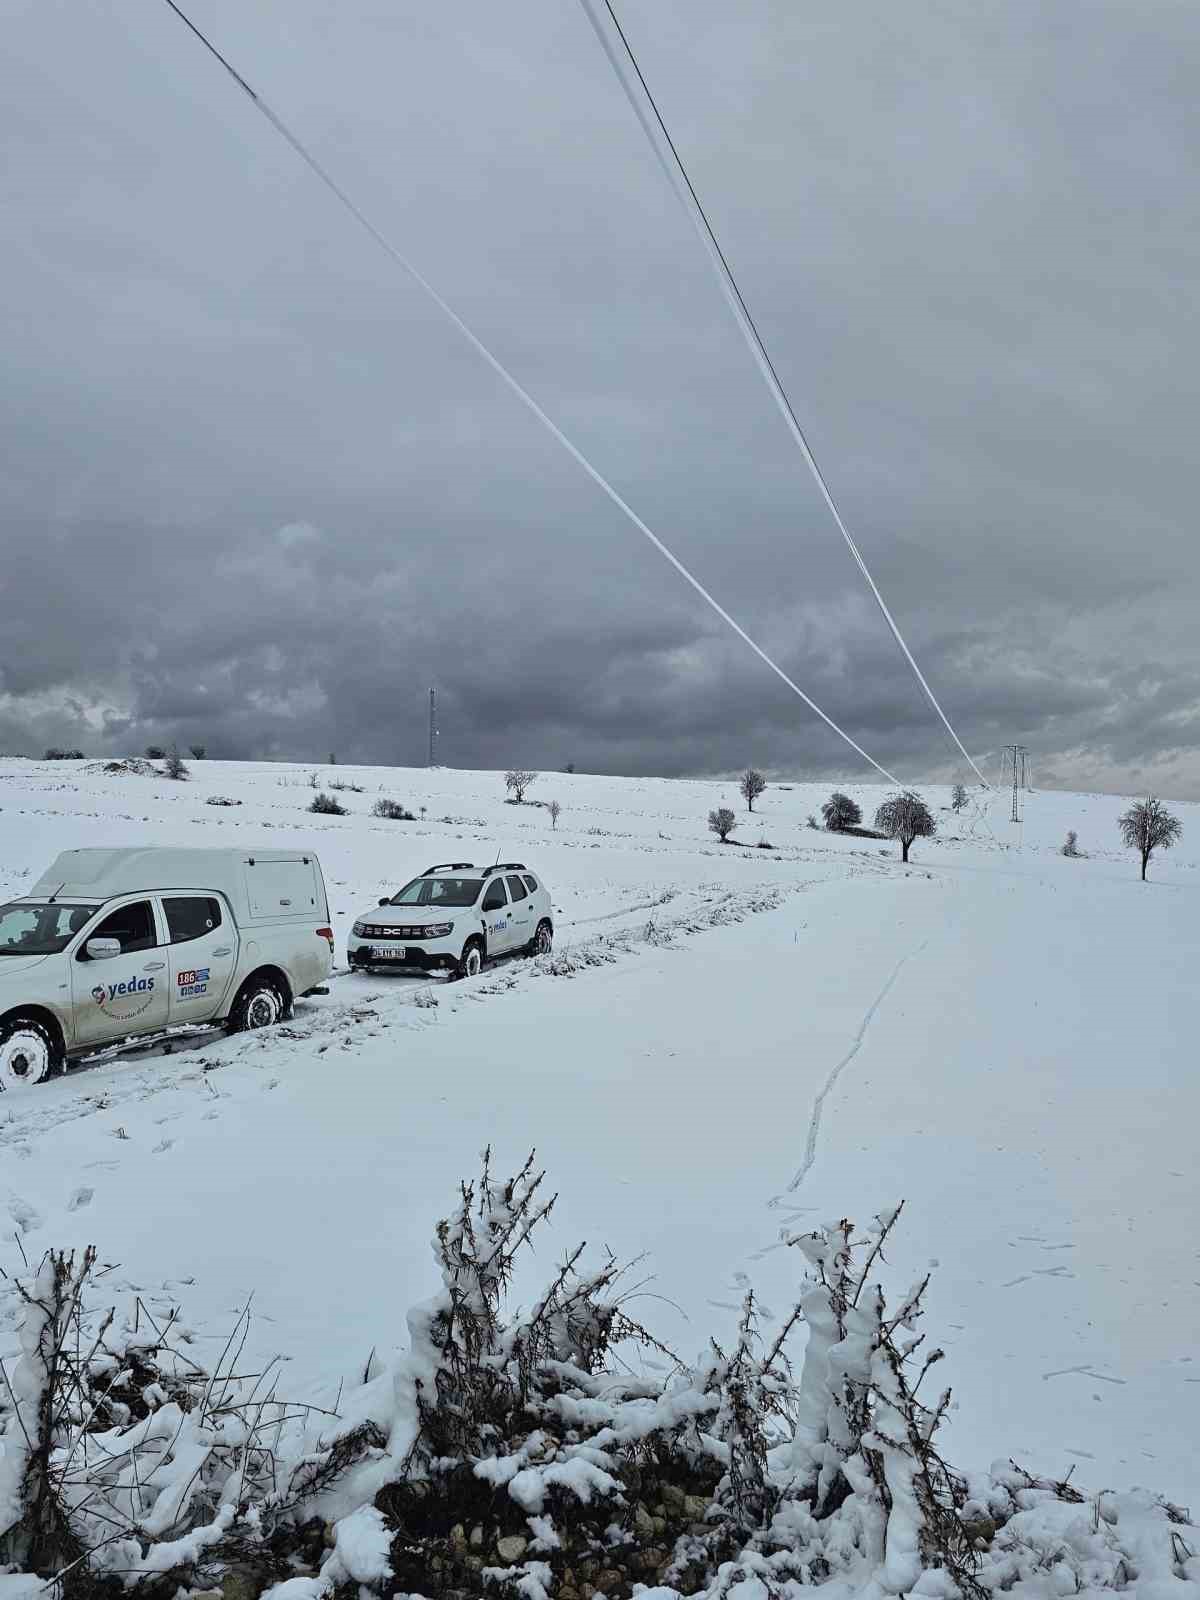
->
[[347, 861, 554, 978]]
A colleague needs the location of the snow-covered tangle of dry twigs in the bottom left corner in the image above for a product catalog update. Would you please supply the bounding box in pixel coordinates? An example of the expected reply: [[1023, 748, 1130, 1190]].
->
[[0, 1248, 384, 1597]]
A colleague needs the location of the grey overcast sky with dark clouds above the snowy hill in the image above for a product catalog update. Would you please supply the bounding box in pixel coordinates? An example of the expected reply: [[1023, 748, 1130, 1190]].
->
[[0, 0, 1200, 797]]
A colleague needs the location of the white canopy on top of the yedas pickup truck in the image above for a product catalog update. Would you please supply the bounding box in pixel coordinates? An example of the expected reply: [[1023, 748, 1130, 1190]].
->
[[22, 848, 330, 923]]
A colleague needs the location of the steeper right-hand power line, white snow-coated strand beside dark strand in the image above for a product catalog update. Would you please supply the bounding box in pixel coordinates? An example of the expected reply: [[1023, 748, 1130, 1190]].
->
[[581, 0, 987, 787]]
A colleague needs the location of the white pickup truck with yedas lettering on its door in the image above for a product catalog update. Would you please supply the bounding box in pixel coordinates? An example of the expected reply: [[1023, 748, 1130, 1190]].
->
[[0, 850, 333, 1090]]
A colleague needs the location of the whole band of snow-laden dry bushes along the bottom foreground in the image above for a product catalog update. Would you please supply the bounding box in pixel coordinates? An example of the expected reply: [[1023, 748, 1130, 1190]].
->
[[0, 1155, 1200, 1600]]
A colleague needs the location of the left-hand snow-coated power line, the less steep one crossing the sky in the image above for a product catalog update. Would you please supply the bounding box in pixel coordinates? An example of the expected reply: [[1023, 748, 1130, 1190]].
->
[[150, 0, 902, 784]]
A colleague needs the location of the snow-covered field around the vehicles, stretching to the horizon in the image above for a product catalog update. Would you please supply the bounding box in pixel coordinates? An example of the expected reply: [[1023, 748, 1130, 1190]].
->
[[0, 760, 1200, 1509]]
